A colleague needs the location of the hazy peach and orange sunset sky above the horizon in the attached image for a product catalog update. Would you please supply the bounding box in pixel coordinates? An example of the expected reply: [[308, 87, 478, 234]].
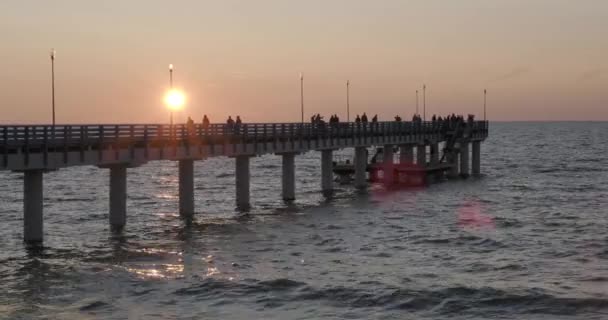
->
[[0, 0, 608, 124]]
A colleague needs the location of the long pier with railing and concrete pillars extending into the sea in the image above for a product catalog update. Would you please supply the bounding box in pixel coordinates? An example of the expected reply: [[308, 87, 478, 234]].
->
[[0, 121, 488, 243]]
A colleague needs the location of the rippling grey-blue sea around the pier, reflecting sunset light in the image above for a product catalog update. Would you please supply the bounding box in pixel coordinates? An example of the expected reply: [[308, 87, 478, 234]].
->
[[0, 122, 608, 320]]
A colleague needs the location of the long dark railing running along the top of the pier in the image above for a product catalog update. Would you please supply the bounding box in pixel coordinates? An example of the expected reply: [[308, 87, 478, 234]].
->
[[0, 121, 488, 152]]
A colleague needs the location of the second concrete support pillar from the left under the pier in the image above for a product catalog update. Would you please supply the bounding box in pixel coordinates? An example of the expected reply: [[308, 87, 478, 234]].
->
[[110, 165, 127, 229]]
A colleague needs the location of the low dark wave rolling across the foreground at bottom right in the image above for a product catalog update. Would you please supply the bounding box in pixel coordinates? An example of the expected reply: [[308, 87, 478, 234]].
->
[[167, 278, 608, 315]]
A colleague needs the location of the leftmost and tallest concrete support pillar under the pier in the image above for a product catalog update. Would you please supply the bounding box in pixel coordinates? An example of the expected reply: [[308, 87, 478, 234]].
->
[[23, 170, 44, 243]]
